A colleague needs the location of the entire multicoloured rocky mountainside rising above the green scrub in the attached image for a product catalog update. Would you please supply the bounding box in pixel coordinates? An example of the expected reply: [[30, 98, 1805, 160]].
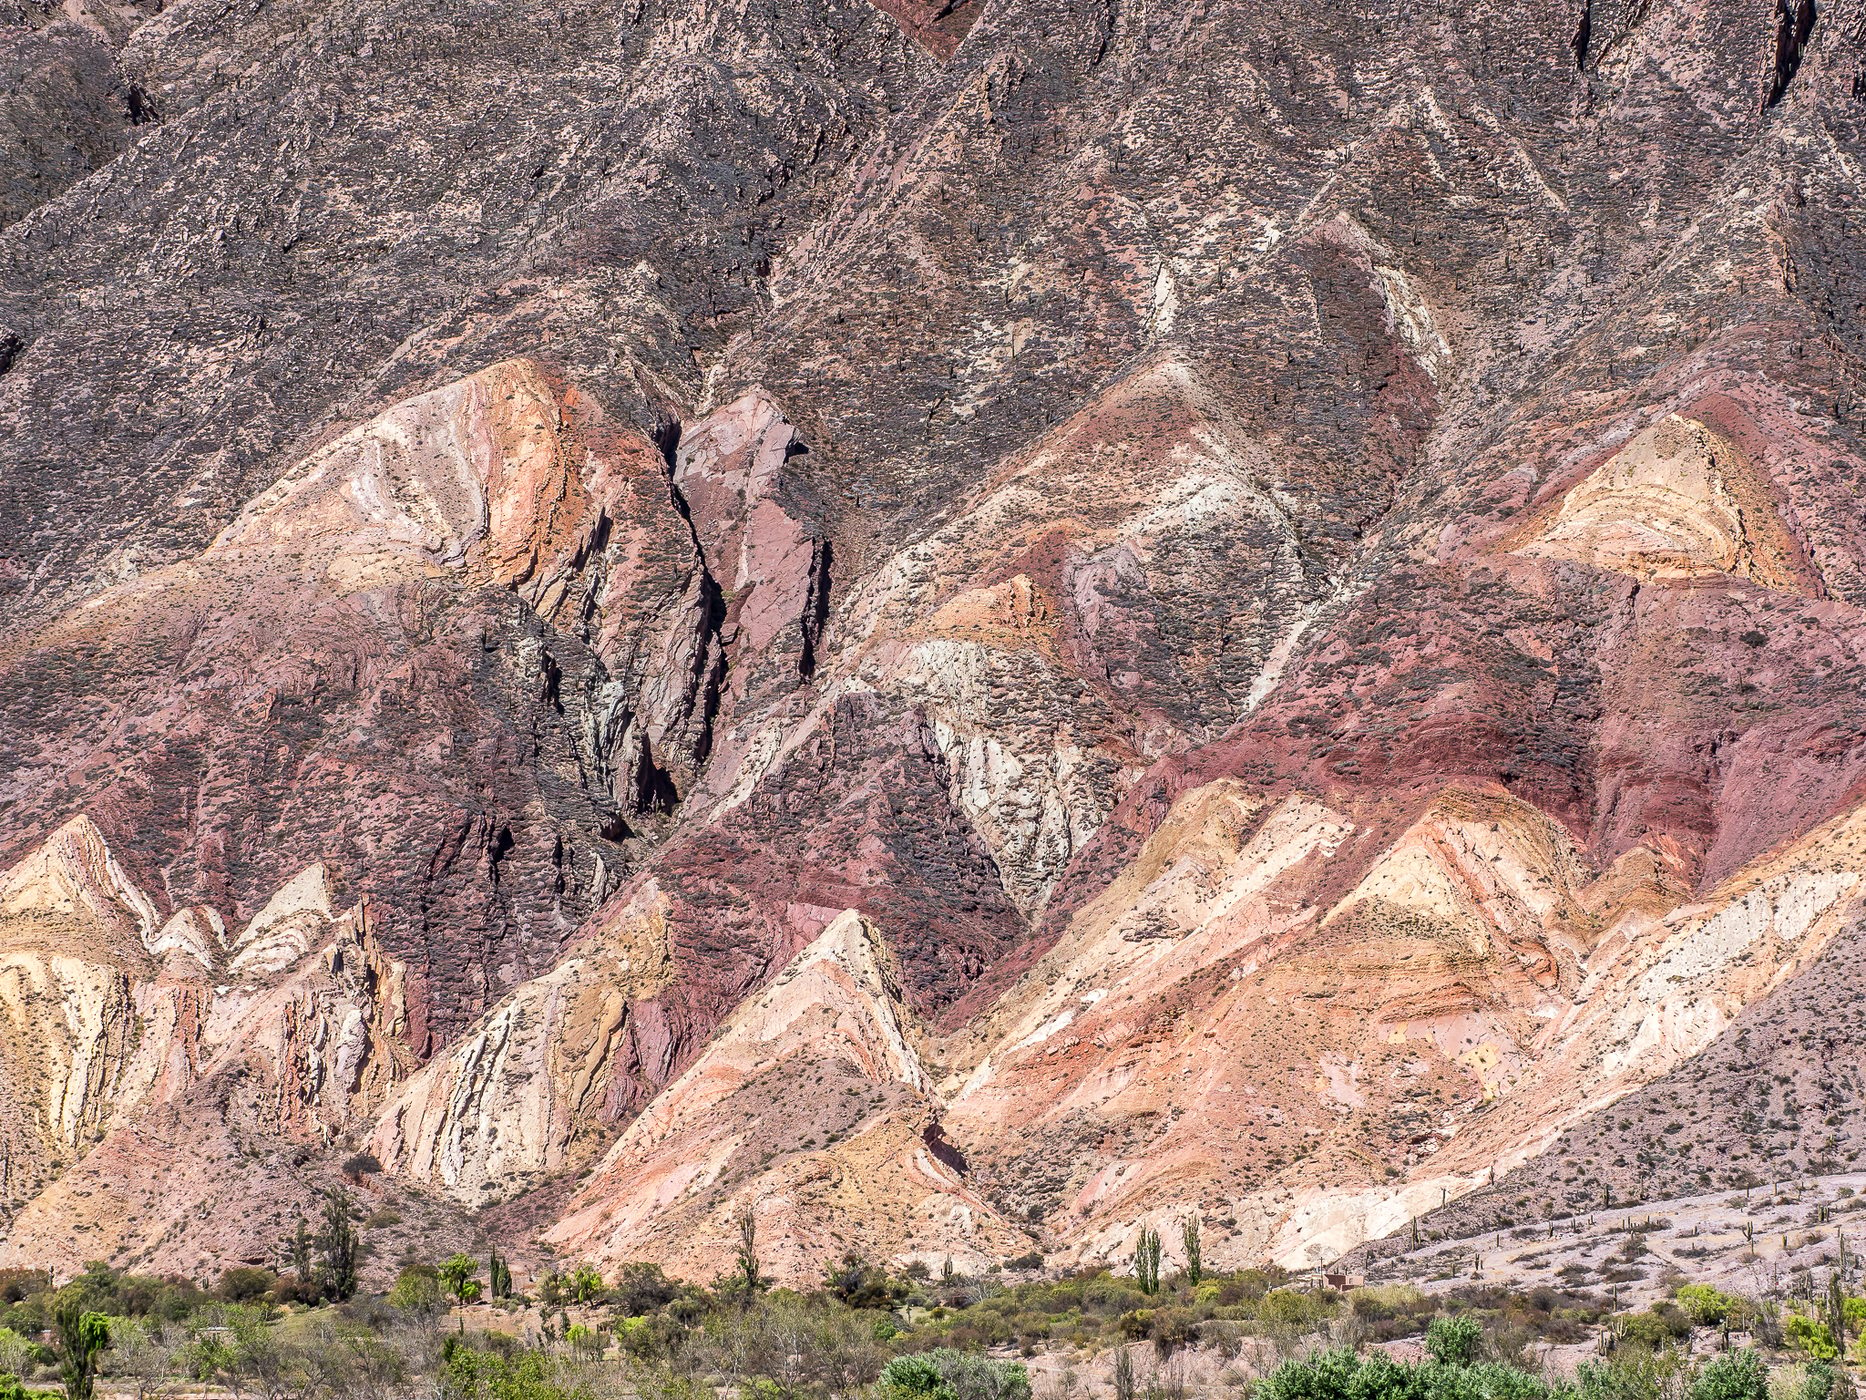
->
[[0, 0, 1866, 1279]]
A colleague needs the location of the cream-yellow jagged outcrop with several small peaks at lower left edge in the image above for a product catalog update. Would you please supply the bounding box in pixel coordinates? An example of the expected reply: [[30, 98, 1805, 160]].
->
[[0, 816, 429, 1267]]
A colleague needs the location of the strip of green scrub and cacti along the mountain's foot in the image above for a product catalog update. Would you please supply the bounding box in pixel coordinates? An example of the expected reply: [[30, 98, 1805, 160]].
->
[[0, 1198, 1866, 1400]]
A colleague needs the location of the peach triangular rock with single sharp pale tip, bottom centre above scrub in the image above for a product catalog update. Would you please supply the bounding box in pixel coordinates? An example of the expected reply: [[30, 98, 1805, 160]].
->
[[545, 909, 1026, 1279]]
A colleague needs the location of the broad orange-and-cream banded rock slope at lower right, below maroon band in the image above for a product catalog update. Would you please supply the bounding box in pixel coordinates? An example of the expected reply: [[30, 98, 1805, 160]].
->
[[948, 782, 1866, 1266]]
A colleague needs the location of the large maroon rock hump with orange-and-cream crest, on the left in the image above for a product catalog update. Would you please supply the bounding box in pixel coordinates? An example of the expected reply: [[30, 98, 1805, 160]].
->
[[0, 360, 715, 1049]]
